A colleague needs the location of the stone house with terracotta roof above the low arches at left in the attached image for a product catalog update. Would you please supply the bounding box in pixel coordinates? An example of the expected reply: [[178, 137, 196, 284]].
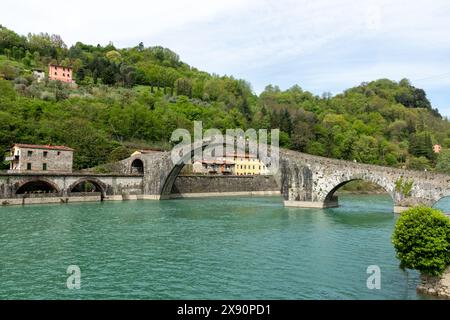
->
[[5, 143, 73, 173]]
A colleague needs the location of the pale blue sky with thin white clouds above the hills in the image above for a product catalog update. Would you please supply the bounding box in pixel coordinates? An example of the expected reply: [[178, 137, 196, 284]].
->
[[0, 0, 450, 116]]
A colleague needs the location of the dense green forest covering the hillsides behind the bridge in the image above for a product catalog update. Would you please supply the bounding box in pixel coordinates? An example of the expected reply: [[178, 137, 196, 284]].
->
[[0, 26, 450, 173]]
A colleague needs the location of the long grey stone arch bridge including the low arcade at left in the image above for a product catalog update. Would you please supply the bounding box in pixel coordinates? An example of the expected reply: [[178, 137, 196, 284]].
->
[[0, 147, 450, 211]]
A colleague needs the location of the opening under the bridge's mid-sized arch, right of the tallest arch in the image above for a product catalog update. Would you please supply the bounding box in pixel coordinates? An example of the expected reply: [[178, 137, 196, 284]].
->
[[324, 178, 394, 212]]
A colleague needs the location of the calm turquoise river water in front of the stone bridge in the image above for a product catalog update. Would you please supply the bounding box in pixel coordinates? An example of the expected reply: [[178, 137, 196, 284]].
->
[[0, 196, 450, 299]]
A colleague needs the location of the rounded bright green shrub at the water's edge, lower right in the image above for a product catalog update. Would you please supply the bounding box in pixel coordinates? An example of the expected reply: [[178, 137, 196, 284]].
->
[[392, 206, 450, 276]]
